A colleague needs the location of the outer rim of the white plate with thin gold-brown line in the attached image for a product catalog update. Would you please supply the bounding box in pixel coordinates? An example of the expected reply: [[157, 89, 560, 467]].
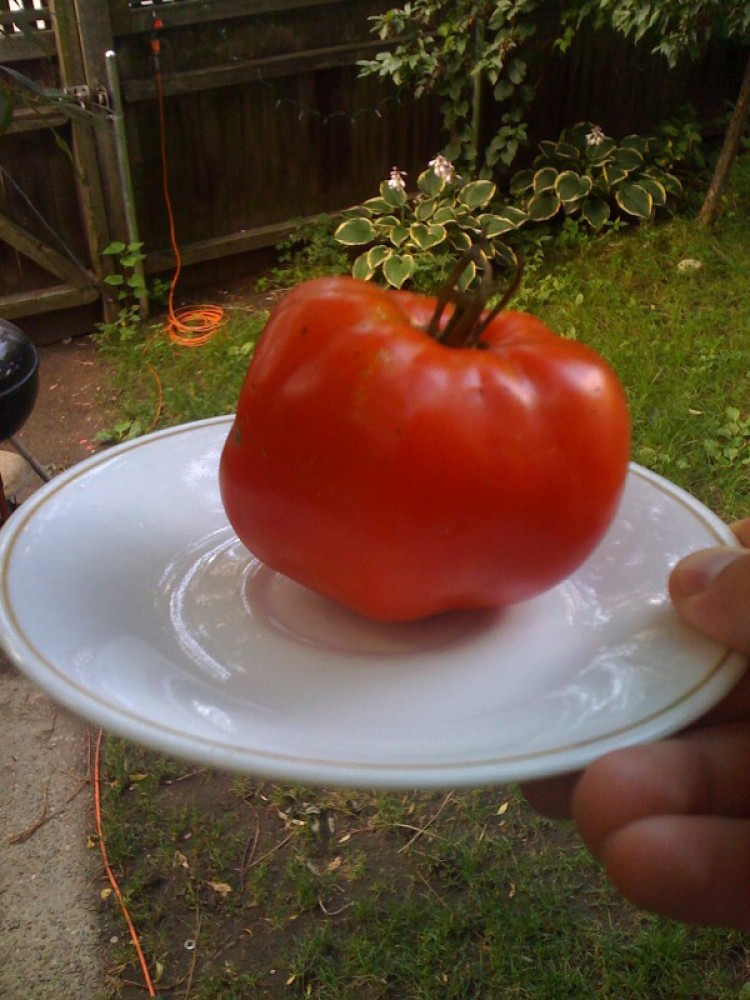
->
[[0, 414, 748, 789]]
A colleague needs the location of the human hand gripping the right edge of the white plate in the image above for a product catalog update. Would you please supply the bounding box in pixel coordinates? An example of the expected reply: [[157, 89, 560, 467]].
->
[[523, 518, 750, 931]]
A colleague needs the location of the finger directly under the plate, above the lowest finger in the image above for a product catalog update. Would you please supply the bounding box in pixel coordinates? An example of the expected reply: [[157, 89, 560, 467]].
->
[[573, 723, 750, 856]]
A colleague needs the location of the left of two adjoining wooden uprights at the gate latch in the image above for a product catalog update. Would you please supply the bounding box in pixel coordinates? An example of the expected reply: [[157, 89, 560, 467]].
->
[[50, 0, 119, 321]]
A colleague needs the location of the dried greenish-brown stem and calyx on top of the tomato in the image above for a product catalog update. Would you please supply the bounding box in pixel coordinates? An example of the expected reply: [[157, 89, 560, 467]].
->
[[426, 247, 523, 348]]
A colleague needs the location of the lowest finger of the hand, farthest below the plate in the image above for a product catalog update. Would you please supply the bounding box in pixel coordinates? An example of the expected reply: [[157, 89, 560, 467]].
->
[[601, 816, 750, 931]]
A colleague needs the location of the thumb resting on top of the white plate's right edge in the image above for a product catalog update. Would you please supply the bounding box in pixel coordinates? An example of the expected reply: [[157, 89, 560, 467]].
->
[[669, 536, 750, 655]]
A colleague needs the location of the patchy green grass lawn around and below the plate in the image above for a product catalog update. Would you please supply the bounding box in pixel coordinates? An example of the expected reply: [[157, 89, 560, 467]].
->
[[101, 158, 750, 1000]]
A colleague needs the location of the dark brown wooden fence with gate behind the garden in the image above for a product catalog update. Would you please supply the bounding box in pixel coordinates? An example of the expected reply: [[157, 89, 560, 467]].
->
[[0, 0, 741, 338]]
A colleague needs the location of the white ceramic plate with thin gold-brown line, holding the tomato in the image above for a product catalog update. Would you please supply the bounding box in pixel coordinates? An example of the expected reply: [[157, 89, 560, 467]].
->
[[0, 417, 745, 788]]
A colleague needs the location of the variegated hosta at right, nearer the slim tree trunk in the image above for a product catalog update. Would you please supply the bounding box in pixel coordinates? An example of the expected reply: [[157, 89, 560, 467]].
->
[[510, 122, 682, 231]]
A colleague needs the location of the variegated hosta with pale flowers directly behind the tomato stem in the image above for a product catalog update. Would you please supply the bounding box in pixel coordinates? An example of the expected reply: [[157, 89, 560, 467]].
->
[[334, 156, 527, 289]]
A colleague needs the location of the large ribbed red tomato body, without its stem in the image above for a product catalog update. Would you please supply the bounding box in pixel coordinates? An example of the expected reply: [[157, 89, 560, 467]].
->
[[219, 278, 630, 621]]
